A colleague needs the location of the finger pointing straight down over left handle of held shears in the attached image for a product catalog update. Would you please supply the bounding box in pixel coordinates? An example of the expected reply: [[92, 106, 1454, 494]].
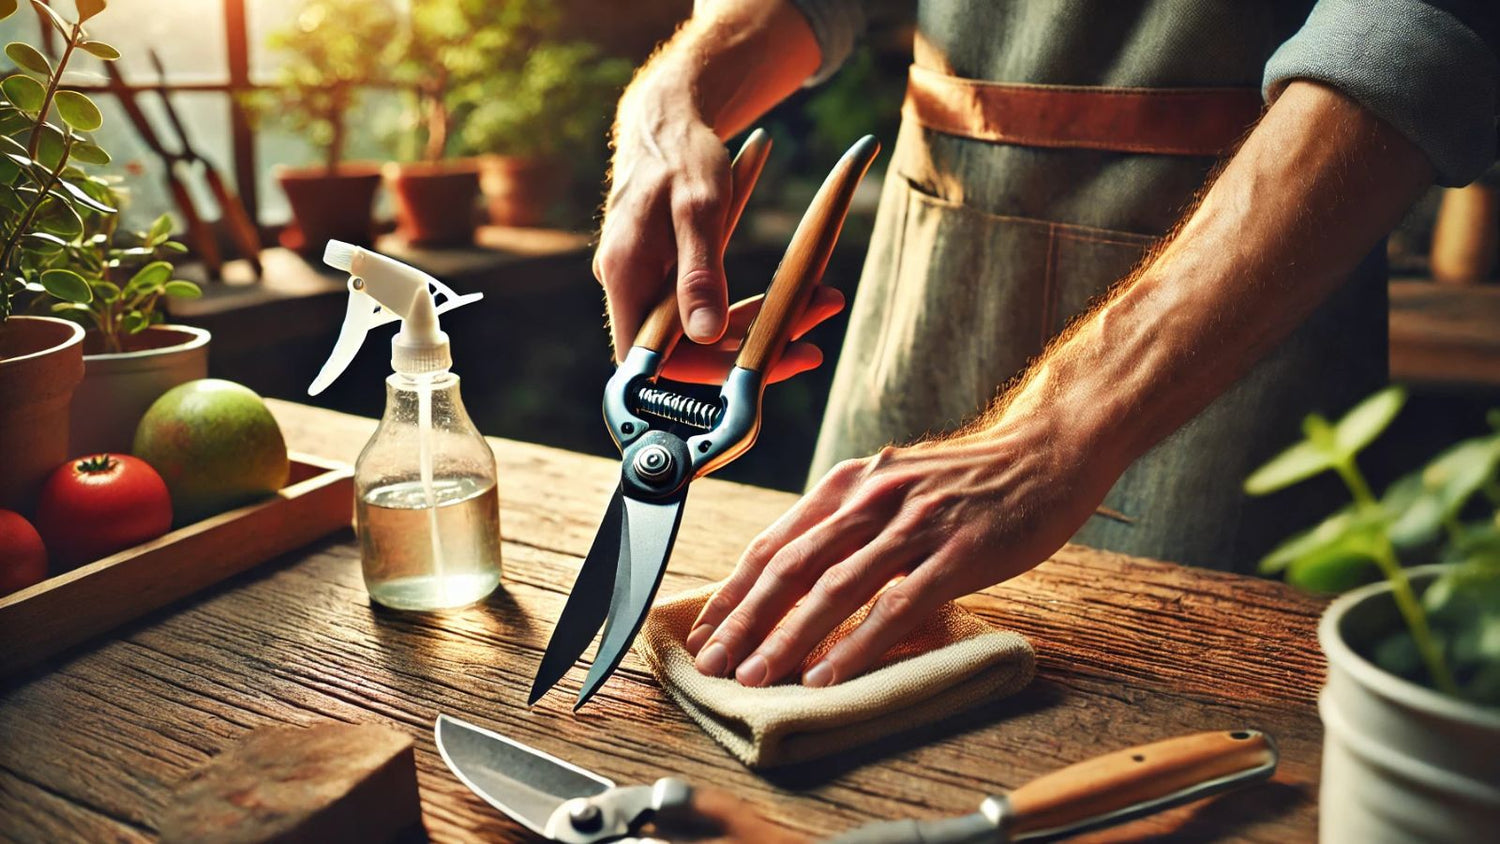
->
[[672, 162, 729, 343]]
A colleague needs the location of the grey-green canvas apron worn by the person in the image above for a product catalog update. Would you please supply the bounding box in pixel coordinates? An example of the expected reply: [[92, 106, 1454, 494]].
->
[[810, 0, 1386, 571]]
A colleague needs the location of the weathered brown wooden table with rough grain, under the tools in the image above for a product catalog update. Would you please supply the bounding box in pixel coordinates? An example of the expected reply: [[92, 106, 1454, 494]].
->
[[0, 402, 1323, 843]]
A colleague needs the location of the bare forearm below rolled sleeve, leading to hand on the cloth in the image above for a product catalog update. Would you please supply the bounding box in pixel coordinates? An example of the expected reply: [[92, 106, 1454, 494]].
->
[[971, 82, 1433, 483]]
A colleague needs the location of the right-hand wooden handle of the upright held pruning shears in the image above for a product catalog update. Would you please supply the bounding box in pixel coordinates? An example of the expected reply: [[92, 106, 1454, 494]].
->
[[735, 135, 881, 375]]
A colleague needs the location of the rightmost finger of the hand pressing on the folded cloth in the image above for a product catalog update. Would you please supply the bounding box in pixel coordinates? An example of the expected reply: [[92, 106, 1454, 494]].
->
[[803, 552, 953, 687]]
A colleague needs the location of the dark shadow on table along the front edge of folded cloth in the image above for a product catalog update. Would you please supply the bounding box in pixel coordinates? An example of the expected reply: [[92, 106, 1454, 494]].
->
[[761, 678, 1064, 790]]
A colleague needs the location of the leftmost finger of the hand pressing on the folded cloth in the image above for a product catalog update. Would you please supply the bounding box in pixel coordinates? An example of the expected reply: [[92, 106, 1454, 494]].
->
[[687, 460, 861, 656]]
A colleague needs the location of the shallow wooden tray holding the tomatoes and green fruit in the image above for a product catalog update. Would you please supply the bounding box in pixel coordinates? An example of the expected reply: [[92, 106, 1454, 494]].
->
[[0, 453, 354, 678]]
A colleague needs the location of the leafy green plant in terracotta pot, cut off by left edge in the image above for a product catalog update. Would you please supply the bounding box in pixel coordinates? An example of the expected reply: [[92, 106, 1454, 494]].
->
[[0, 0, 119, 511]]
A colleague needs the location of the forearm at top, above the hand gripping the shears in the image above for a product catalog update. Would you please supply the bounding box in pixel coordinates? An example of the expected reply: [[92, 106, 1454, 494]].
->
[[620, 0, 821, 138]]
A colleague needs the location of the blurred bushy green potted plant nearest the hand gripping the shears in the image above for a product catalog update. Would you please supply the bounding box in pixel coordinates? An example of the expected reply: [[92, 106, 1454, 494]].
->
[[459, 40, 630, 226]]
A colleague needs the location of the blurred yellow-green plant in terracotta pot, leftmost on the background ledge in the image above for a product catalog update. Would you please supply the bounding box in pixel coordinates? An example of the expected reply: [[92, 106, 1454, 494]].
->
[[261, 0, 396, 252]]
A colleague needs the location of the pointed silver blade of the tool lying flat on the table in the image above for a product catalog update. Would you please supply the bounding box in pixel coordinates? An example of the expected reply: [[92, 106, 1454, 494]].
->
[[434, 715, 615, 835]]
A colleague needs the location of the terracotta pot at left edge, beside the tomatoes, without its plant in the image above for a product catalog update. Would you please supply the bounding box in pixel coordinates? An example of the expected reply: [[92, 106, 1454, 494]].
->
[[0, 316, 84, 516]]
